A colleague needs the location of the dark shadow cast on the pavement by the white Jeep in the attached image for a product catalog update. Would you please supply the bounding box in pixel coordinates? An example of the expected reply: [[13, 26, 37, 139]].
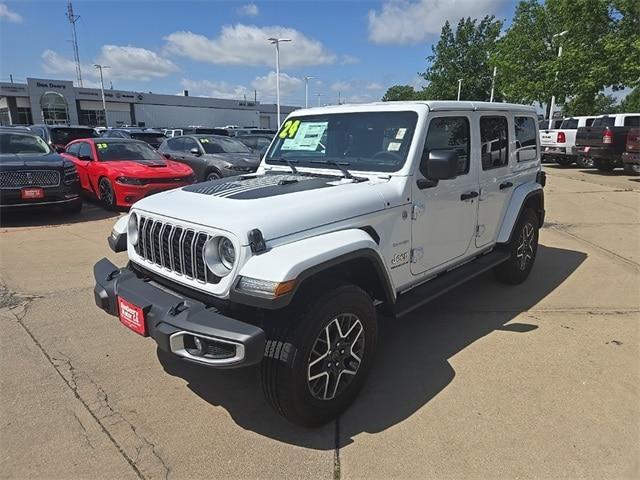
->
[[158, 245, 587, 450]]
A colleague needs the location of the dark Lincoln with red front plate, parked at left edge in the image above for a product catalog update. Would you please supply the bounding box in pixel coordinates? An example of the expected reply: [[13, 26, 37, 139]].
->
[[0, 129, 82, 213]]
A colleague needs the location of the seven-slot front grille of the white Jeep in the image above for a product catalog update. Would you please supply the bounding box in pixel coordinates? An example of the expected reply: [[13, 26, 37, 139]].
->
[[135, 217, 220, 283]]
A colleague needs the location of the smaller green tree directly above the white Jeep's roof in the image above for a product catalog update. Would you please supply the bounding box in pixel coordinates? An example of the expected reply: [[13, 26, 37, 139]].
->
[[421, 16, 502, 100]]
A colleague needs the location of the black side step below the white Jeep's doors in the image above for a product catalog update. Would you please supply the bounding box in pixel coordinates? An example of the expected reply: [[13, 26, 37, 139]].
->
[[390, 250, 509, 317]]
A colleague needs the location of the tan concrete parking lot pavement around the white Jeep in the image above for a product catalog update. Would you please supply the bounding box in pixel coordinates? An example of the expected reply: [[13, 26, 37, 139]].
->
[[0, 166, 640, 479]]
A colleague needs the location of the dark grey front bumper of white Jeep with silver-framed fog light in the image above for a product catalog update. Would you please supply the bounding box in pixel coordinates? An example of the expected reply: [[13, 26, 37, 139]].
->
[[93, 258, 265, 368]]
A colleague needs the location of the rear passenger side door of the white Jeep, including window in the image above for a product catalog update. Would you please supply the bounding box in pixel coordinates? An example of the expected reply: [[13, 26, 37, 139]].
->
[[476, 112, 515, 248]]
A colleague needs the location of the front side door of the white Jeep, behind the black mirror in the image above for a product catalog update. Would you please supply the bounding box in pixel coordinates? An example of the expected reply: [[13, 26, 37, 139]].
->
[[411, 113, 478, 275]]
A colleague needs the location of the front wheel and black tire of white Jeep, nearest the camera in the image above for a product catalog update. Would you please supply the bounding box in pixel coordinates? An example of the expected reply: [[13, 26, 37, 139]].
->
[[262, 285, 378, 426]]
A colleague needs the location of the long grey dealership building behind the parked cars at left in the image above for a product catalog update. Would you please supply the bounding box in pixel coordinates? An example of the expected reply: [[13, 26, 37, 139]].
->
[[0, 78, 297, 128]]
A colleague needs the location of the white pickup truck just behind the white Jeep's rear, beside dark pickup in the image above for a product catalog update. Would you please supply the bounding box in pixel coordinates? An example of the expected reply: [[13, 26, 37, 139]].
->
[[540, 116, 596, 168]]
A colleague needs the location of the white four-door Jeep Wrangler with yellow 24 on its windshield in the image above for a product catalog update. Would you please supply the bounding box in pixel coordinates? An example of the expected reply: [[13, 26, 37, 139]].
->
[[94, 101, 545, 425]]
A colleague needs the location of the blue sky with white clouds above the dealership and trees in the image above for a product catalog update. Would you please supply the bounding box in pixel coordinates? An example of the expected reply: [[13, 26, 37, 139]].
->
[[0, 0, 515, 105]]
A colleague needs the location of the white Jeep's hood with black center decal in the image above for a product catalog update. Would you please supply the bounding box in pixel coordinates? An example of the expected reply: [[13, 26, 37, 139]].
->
[[135, 173, 385, 245]]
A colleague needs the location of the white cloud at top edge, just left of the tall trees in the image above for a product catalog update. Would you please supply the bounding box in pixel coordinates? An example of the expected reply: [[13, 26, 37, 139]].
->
[[369, 0, 504, 44]]
